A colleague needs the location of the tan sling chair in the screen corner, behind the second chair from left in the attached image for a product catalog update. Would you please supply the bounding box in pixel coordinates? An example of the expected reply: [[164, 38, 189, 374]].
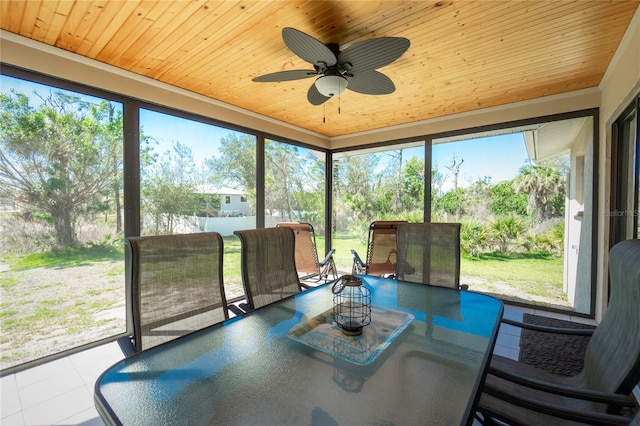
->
[[276, 222, 338, 281]]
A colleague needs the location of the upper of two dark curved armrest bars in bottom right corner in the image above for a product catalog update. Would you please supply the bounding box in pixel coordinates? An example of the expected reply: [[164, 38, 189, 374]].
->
[[486, 366, 636, 407]]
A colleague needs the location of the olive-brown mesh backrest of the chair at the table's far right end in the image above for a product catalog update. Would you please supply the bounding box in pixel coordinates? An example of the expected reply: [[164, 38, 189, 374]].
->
[[396, 223, 461, 289]]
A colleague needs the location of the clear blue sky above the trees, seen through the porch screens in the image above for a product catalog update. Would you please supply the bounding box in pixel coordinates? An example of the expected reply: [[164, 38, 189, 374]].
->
[[0, 75, 527, 191]]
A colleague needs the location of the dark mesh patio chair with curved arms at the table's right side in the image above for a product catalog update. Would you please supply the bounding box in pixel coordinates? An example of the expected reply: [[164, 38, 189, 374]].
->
[[478, 240, 640, 426]]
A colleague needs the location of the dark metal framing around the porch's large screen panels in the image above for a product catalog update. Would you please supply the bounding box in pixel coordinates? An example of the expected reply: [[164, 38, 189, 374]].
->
[[0, 63, 600, 374]]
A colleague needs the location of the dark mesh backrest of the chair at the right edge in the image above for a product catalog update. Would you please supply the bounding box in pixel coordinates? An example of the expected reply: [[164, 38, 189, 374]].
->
[[583, 239, 640, 394]]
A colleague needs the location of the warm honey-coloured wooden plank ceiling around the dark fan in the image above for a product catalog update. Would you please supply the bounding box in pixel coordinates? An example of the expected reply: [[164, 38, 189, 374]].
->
[[0, 0, 640, 137]]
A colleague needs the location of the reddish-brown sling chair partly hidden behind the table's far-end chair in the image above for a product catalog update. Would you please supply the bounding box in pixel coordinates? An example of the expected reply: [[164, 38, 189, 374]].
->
[[351, 220, 407, 277]]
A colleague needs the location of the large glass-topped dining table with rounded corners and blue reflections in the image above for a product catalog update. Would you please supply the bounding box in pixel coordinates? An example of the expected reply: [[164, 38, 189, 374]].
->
[[95, 276, 503, 425]]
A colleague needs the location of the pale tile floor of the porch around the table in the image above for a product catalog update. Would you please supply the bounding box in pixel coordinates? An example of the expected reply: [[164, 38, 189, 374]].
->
[[0, 306, 595, 426]]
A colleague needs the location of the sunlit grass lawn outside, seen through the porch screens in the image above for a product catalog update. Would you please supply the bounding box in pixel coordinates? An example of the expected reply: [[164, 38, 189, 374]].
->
[[0, 231, 571, 368]]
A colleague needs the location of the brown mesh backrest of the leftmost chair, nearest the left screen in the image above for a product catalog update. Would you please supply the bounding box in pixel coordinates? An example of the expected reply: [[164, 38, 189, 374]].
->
[[125, 232, 229, 351]]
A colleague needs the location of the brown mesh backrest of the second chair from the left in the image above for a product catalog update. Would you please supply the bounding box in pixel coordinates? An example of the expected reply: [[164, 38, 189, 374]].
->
[[235, 227, 300, 309]]
